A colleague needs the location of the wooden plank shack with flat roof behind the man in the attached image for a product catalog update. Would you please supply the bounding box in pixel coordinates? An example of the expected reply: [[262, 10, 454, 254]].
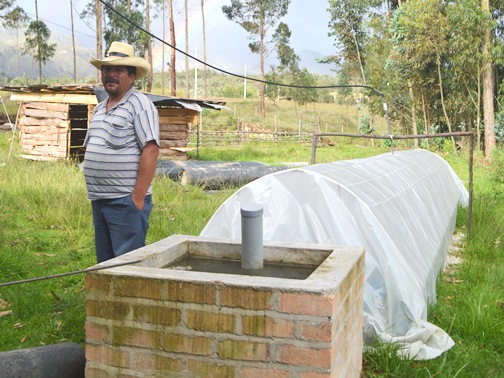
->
[[0, 84, 224, 161]]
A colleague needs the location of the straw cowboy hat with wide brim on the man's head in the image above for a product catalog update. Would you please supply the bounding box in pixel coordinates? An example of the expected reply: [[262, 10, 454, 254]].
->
[[89, 42, 150, 79]]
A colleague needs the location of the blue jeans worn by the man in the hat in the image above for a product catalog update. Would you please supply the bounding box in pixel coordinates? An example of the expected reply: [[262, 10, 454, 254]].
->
[[91, 194, 152, 263]]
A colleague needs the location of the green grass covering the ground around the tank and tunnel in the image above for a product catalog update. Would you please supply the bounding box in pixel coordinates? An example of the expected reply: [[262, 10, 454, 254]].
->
[[0, 133, 504, 377]]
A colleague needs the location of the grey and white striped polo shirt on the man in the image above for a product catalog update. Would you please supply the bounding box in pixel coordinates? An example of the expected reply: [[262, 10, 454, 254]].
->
[[84, 87, 159, 200]]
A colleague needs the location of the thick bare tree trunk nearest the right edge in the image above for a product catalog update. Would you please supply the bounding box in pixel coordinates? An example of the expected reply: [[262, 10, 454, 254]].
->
[[482, 0, 496, 159]]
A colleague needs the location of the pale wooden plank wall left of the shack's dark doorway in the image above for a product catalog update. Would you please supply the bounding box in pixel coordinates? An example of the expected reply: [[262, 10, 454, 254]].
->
[[19, 102, 70, 158]]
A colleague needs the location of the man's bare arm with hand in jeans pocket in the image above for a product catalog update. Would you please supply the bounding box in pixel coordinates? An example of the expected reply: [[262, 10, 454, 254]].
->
[[132, 140, 159, 210]]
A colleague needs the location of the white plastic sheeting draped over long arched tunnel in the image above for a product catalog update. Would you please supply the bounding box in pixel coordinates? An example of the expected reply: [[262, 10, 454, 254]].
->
[[200, 150, 468, 359]]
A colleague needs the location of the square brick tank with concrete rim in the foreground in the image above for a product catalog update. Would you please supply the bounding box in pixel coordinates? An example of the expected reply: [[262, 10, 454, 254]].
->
[[86, 235, 364, 378]]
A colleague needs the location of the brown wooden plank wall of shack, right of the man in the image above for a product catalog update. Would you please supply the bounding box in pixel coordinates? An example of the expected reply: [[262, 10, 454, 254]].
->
[[158, 108, 198, 160]]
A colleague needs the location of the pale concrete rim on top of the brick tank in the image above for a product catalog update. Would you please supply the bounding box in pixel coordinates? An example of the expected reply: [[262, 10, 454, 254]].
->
[[90, 235, 364, 294]]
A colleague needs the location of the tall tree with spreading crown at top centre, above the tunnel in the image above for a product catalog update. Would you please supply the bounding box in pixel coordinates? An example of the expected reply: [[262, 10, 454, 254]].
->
[[222, 0, 290, 118]]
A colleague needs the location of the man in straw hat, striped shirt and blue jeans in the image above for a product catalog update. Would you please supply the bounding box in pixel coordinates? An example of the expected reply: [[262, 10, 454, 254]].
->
[[84, 42, 159, 263]]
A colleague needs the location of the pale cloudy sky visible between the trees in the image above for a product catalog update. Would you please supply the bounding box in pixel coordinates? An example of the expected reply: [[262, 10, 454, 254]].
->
[[16, 0, 335, 74]]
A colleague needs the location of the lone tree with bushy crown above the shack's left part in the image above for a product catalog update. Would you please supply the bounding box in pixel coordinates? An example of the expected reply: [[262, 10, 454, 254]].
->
[[24, 0, 56, 84]]
